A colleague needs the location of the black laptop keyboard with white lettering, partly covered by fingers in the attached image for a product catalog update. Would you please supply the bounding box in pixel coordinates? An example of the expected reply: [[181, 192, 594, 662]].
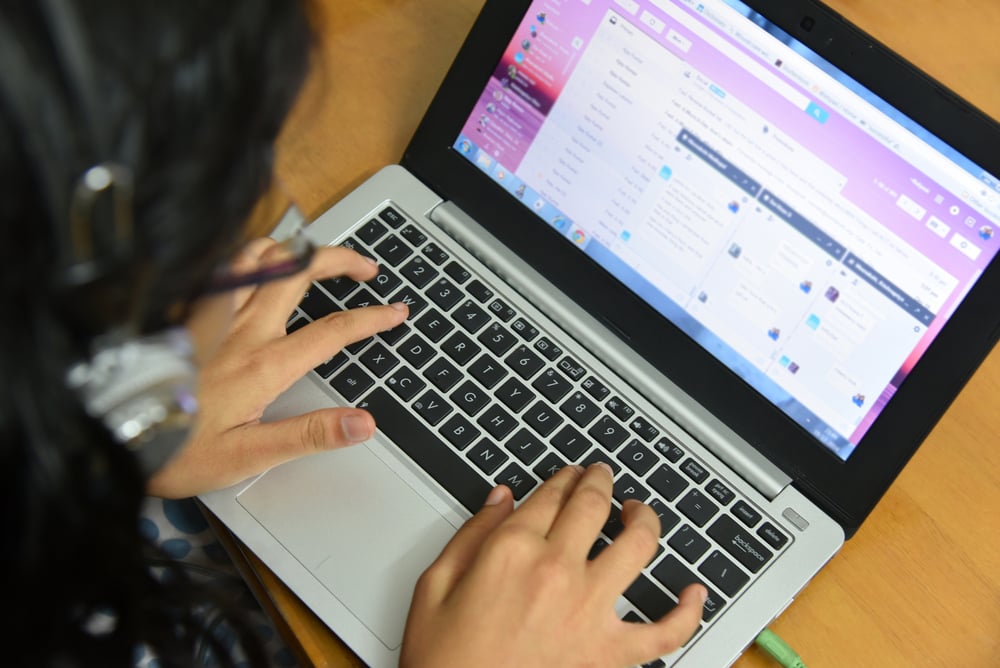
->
[[288, 206, 789, 648]]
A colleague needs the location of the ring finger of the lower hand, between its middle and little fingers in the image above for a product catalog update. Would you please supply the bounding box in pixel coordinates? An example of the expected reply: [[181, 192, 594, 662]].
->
[[591, 500, 660, 599]]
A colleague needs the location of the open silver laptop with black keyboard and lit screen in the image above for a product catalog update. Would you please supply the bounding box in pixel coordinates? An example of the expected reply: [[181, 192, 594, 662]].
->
[[202, 0, 1000, 666]]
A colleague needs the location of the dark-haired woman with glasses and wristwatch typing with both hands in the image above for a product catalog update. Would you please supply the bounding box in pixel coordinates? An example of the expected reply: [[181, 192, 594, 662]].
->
[[0, 0, 704, 666]]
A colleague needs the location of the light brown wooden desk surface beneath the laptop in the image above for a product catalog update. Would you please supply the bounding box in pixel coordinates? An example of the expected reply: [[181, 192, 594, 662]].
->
[[236, 0, 1000, 668]]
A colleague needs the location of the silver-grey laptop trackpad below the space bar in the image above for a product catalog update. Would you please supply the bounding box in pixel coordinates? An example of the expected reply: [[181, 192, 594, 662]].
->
[[237, 445, 455, 649]]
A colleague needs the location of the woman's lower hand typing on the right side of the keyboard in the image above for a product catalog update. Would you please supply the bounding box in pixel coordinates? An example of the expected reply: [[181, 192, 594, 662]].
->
[[400, 465, 707, 668]]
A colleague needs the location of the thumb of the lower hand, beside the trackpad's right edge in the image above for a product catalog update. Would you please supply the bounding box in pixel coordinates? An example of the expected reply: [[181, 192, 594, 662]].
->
[[419, 485, 514, 604]]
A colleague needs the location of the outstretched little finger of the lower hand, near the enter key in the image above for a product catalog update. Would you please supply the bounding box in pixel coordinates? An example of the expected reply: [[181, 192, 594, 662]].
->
[[620, 584, 707, 665]]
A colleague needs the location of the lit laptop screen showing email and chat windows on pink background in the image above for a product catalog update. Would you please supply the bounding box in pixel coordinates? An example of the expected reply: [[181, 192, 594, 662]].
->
[[453, 0, 1000, 460]]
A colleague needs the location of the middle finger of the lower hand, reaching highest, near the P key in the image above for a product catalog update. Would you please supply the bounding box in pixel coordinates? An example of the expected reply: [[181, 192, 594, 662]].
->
[[548, 463, 614, 556]]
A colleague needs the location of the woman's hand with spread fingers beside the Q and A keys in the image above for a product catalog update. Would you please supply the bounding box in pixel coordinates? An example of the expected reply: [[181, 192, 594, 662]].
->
[[148, 239, 408, 498]]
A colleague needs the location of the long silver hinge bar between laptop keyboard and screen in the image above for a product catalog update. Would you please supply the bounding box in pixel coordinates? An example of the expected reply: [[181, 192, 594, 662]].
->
[[427, 202, 791, 500]]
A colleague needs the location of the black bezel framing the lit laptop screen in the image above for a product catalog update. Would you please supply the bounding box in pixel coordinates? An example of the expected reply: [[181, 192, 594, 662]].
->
[[402, 0, 1000, 536]]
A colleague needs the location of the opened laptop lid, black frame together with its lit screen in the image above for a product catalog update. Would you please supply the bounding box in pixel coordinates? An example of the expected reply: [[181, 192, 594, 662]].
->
[[403, 0, 1000, 535]]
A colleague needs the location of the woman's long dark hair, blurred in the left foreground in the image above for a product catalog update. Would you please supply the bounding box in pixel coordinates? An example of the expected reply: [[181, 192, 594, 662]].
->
[[0, 0, 311, 666]]
